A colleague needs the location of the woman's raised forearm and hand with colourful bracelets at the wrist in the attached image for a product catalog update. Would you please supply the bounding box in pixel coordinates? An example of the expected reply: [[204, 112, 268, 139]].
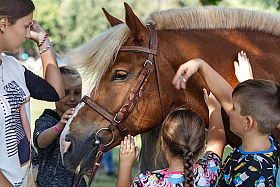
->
[[30, 20, 64, 99]]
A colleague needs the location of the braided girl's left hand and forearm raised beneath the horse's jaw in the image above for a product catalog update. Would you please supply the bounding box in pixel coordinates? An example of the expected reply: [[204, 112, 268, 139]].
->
[[116, 135, 139, 187]]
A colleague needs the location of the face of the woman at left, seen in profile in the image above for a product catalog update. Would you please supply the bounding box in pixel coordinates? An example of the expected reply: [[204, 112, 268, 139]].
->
[[0, 12, 33, 53]]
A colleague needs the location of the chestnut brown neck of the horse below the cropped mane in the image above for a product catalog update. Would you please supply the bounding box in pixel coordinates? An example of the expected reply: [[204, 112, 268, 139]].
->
[[157, 29, 280, 122]]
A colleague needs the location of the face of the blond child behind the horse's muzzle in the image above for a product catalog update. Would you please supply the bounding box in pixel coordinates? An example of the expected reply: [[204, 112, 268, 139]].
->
[[55, 75, 82, 117]]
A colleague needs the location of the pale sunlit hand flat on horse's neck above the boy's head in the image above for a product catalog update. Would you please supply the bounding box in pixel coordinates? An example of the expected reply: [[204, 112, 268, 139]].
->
[[234, 51, 253, 82]]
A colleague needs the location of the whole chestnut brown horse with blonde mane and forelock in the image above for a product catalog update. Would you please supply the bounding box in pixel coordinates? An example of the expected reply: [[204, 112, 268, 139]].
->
[[61, 3, 280, 173]]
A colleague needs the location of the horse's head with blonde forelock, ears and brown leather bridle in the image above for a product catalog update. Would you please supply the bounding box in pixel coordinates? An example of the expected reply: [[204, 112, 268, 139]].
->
[[61, 3, 162, 173]]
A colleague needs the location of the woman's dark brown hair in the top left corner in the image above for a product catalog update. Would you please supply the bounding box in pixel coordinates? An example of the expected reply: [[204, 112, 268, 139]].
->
[[0, 0, 35, 24]]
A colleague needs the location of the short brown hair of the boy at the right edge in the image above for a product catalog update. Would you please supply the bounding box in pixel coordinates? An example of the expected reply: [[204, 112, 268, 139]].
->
[[232, 79, 280, 134]]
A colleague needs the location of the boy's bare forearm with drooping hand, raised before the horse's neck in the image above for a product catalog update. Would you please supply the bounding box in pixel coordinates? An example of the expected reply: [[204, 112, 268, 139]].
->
[[172, 58, 232, 115]]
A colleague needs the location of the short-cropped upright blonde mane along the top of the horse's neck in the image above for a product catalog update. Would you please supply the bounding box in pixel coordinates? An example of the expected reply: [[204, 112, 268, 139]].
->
[[146, 6, 280, 33]]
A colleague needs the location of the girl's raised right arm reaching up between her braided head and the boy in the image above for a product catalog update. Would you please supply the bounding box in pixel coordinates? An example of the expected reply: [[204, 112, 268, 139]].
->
[[203, 89, 226, 159]]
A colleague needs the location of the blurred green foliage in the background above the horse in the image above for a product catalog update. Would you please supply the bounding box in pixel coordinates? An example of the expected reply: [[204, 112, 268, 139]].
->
[[21, 0, 280, 55]]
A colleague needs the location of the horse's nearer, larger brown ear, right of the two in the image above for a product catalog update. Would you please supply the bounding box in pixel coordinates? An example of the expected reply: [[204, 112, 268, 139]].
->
[[124, 3, 150, 41]]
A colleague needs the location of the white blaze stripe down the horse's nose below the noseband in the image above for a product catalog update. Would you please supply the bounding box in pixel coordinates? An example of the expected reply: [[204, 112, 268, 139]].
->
[[60, 103, 85, 158]]
